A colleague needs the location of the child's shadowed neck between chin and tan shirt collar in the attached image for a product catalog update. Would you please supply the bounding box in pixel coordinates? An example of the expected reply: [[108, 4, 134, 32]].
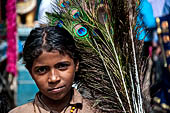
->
[[40, 90, 72, 112]]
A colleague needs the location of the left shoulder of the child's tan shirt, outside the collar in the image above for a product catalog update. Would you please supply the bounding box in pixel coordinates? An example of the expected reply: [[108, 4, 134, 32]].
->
[[9, 102, 34, 113]]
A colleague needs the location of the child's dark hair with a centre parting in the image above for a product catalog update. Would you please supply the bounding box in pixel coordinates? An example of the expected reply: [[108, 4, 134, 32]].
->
[[23, 26, 80, 70]]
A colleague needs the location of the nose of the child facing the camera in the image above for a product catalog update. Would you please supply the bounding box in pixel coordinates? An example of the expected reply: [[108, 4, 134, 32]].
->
[[48, 69, 60, 83]]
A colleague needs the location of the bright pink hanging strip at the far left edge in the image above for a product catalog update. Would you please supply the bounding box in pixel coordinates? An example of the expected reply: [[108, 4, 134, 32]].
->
[[6, 0, 17, 76]]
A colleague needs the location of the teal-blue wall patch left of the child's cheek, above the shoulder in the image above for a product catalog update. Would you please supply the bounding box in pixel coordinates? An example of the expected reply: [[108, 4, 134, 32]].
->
[[16, 64, 38, 106]]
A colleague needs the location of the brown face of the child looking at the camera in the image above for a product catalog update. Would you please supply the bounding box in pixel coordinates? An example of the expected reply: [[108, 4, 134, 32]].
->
[[30, 51, 78, 100]]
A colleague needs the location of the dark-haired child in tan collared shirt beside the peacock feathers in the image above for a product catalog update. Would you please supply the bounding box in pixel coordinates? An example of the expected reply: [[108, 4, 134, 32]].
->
[[9, 27, 98, 113]]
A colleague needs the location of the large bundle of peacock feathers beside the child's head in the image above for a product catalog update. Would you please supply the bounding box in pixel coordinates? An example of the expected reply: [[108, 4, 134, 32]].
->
[[47, 0, 145, 113]]
